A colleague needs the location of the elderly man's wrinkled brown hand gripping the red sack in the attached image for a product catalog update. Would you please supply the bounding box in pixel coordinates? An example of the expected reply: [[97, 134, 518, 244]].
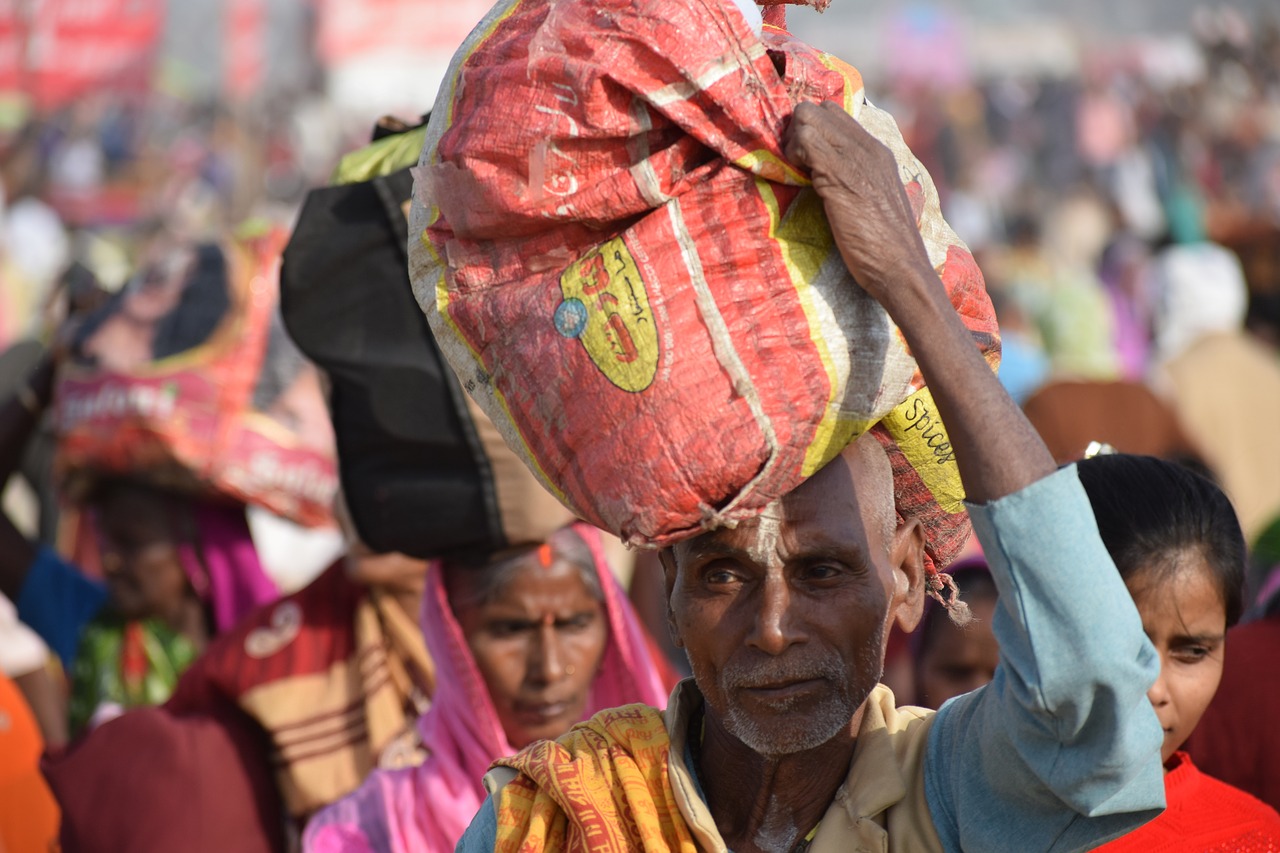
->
[[783, 101, 932, 308]]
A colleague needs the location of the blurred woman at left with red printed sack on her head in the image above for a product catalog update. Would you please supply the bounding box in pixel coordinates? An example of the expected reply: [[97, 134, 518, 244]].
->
[[0, 199, 337, 745]]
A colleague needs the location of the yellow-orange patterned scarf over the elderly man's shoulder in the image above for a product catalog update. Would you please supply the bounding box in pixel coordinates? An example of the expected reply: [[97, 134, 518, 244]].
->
[[494, 704, 698, 853]]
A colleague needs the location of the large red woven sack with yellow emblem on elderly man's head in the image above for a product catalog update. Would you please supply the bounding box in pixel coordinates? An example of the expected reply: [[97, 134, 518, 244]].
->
[[410, 0, 998, 565]]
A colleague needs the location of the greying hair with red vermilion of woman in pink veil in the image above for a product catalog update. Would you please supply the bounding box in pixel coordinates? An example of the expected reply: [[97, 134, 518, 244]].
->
[[443, 528, 608, 612]]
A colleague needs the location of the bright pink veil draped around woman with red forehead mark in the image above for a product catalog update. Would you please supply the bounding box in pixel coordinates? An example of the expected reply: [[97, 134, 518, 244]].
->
[[302, 523, 668, 853]]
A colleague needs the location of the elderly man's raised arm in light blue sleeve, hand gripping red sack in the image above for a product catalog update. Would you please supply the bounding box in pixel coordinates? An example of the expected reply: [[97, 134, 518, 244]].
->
[[787, 96, 1164, 853]]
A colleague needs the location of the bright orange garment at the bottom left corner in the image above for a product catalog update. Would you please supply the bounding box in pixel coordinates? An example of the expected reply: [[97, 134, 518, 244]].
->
[[0, 674, 60, 853]]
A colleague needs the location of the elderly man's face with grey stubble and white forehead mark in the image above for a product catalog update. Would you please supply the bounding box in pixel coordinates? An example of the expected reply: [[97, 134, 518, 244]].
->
[[664, 435, 924, 754]]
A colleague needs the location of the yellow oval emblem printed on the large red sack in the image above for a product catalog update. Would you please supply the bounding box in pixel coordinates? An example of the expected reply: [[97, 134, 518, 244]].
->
[[554, 237, 658, 393]]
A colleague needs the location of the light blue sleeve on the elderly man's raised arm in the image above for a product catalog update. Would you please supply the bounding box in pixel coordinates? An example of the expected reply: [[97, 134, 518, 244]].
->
[[924, 466, 1165, 853]]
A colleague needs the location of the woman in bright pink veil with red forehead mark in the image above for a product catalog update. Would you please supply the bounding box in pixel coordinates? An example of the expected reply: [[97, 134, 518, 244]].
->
[[303, 524, 673, 853]]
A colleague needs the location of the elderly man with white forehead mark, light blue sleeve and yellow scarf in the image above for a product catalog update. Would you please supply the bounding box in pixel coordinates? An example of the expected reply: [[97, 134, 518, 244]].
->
[[458, 104, 1164, 853]]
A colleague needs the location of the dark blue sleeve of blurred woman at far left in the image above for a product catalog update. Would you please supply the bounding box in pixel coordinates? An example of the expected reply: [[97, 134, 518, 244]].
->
[[14, 546, 106, 671]]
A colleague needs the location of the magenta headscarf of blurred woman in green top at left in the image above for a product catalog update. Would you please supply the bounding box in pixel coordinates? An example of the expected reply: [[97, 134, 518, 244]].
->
[[178, 501, 280, 634]]
